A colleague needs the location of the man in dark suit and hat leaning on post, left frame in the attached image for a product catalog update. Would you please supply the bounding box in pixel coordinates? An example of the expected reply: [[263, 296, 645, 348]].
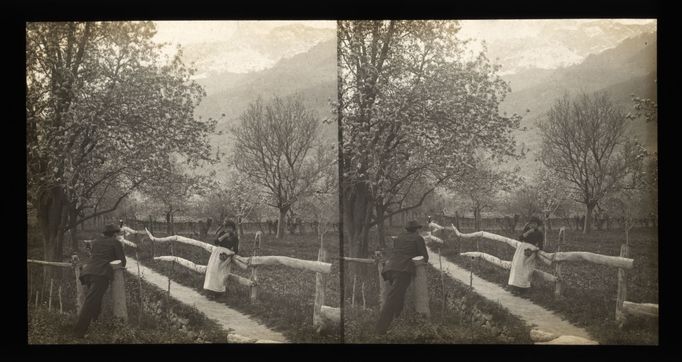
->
[[74, 224, 126, 338]]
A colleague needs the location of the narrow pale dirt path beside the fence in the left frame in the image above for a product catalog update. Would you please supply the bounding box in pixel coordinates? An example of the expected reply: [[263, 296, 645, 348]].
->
[[126, 256, 288, 343]]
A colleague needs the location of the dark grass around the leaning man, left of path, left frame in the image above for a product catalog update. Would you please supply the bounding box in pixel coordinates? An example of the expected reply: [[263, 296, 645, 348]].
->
[[27, 226, 227, 344]]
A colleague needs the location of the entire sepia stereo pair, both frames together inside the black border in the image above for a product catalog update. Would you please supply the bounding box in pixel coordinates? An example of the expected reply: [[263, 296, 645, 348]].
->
[[22, 18, 659, 346]]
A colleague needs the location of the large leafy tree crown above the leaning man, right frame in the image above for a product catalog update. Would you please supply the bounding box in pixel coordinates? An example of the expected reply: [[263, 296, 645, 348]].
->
[[337, 21, 520, 254]]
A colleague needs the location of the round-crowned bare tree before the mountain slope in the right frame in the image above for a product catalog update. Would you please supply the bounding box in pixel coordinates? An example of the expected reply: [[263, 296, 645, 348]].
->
[[540, 93, 641, 233]]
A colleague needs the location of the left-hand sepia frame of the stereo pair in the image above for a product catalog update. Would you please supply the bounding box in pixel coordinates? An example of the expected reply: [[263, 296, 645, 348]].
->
[[26, 21, 341, 344]]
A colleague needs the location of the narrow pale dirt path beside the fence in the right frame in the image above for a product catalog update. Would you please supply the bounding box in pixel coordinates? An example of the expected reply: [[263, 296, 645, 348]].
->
[[427, 248, 594, 344]]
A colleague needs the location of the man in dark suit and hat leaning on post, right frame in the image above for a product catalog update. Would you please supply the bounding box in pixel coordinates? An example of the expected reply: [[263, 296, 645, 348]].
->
[[376, 221, 429, 334]]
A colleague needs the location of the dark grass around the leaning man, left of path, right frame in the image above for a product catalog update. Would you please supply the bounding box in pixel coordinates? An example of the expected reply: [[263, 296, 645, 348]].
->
[[344, 230, 532, 344]]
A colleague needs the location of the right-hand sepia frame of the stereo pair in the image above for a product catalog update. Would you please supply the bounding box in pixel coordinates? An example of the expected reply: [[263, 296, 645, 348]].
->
[[337, 19, 658, 345]]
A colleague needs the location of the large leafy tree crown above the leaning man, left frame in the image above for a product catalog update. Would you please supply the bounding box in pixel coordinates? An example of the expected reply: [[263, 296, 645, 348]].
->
[[26, 22, 215, 257]]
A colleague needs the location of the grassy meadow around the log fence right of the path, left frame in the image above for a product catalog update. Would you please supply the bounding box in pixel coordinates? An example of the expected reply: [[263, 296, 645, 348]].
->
[[126, 229, 341, 343]]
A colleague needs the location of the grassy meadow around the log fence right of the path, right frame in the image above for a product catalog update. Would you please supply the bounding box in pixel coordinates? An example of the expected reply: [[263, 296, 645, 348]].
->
[[432, 229, 658, 345]]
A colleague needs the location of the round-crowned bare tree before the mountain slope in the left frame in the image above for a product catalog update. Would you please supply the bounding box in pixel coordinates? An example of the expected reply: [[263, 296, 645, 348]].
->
[[232, 96, 333, 238]]
